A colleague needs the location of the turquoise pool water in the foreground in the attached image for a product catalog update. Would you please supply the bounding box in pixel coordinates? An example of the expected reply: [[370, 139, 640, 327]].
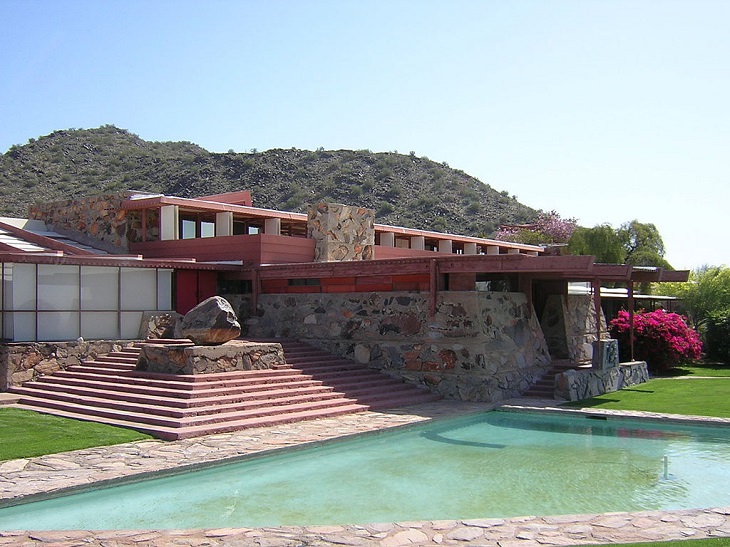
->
[[0, 412, 730, 530]]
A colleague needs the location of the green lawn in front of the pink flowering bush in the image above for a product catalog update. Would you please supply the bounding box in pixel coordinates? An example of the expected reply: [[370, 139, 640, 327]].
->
[[562, 376, 730, 418]]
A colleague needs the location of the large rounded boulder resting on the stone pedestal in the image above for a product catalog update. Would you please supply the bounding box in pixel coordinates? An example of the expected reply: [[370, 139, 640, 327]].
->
[[180, 296, 241, 346]]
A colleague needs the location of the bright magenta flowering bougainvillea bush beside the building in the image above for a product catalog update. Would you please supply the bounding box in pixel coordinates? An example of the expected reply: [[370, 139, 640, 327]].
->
[[610, 309, 702, 372]]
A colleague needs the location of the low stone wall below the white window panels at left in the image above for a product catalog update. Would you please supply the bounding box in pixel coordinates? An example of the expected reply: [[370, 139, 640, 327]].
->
[[0, 340, 134, 391]]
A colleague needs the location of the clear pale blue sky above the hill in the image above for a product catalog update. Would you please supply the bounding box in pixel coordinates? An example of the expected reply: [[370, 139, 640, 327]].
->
[[0, 0, 730, 269]]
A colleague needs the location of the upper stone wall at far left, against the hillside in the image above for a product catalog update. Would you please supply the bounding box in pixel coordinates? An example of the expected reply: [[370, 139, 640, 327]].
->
[[28, 193, 158, 251]]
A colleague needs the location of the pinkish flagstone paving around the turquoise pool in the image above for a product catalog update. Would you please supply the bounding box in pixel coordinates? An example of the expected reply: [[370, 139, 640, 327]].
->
[[0, 399, 730, 547]]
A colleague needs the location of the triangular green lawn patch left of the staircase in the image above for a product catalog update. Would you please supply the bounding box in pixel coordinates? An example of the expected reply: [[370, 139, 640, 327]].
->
[[0, 408, 152, 461]]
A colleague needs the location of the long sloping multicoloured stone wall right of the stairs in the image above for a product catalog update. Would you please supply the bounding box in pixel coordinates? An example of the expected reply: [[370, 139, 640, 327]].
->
[[242, 291, 550, 401]]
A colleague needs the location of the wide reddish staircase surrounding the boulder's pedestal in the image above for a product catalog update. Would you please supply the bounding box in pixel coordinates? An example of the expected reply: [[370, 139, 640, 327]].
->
[[10, 340, 439, 440]]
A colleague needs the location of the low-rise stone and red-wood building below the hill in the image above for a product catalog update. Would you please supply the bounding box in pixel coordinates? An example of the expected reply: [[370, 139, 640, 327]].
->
[[0, 192, 687, 401]]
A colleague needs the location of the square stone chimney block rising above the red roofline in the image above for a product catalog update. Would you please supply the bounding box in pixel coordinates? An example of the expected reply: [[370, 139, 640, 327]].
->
[[307, 203, 375, 262]]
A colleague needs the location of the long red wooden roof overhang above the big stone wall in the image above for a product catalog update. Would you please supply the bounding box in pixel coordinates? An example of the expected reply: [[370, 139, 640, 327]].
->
[[229, 254, 689, 359]]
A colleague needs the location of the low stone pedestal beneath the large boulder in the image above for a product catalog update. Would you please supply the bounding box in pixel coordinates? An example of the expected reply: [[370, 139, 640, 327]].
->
[[137, 340, 286, 374]]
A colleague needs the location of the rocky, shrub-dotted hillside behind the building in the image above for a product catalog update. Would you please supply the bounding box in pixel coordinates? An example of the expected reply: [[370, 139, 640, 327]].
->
[[0, 126, 537, 236]]
